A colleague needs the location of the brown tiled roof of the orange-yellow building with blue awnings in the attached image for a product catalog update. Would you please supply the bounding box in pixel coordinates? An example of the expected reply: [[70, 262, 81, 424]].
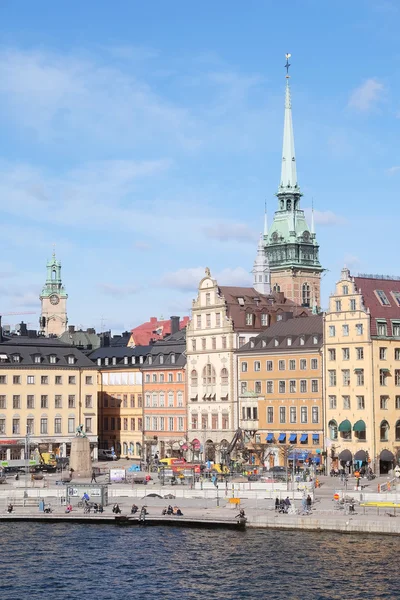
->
[[237, 315, 323, 353]]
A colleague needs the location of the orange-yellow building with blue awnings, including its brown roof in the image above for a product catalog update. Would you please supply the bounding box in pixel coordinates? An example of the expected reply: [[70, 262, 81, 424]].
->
[[237, 315, 323, 466]]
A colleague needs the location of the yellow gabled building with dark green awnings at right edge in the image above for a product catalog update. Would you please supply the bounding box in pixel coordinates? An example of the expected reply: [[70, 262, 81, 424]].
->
[[324, 269, 400, 473]]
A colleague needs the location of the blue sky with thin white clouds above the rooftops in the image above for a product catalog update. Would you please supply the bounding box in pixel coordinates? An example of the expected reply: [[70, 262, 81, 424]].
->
[[0, 0, 400, 331]]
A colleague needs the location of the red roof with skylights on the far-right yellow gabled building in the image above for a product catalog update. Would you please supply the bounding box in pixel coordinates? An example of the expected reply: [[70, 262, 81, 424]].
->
[[354, 277, 400, 336]]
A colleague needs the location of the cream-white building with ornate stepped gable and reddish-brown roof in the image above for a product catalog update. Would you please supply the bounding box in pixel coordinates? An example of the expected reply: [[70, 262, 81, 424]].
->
[[186, 269, 308, 462]]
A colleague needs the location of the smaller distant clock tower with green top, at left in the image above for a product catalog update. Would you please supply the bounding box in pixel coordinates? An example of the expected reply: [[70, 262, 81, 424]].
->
[[39, 252, 68, 336]]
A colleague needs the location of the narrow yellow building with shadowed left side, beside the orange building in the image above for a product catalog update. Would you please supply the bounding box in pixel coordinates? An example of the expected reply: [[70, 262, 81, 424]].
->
[[90, 346, 147, 460]]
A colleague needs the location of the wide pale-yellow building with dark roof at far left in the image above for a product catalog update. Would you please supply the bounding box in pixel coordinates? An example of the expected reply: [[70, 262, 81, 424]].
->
[[0, 335, 97, 460]]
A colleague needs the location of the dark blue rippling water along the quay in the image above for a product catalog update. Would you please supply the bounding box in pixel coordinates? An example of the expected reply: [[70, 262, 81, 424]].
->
[[0, 523, 400, 600]]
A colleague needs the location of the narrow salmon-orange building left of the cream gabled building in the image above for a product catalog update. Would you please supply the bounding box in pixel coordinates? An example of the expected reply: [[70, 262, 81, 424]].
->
[[142, 330, 188, 462]]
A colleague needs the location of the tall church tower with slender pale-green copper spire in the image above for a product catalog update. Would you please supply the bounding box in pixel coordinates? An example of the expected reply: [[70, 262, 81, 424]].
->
[[265, 54, 323, 307]]
